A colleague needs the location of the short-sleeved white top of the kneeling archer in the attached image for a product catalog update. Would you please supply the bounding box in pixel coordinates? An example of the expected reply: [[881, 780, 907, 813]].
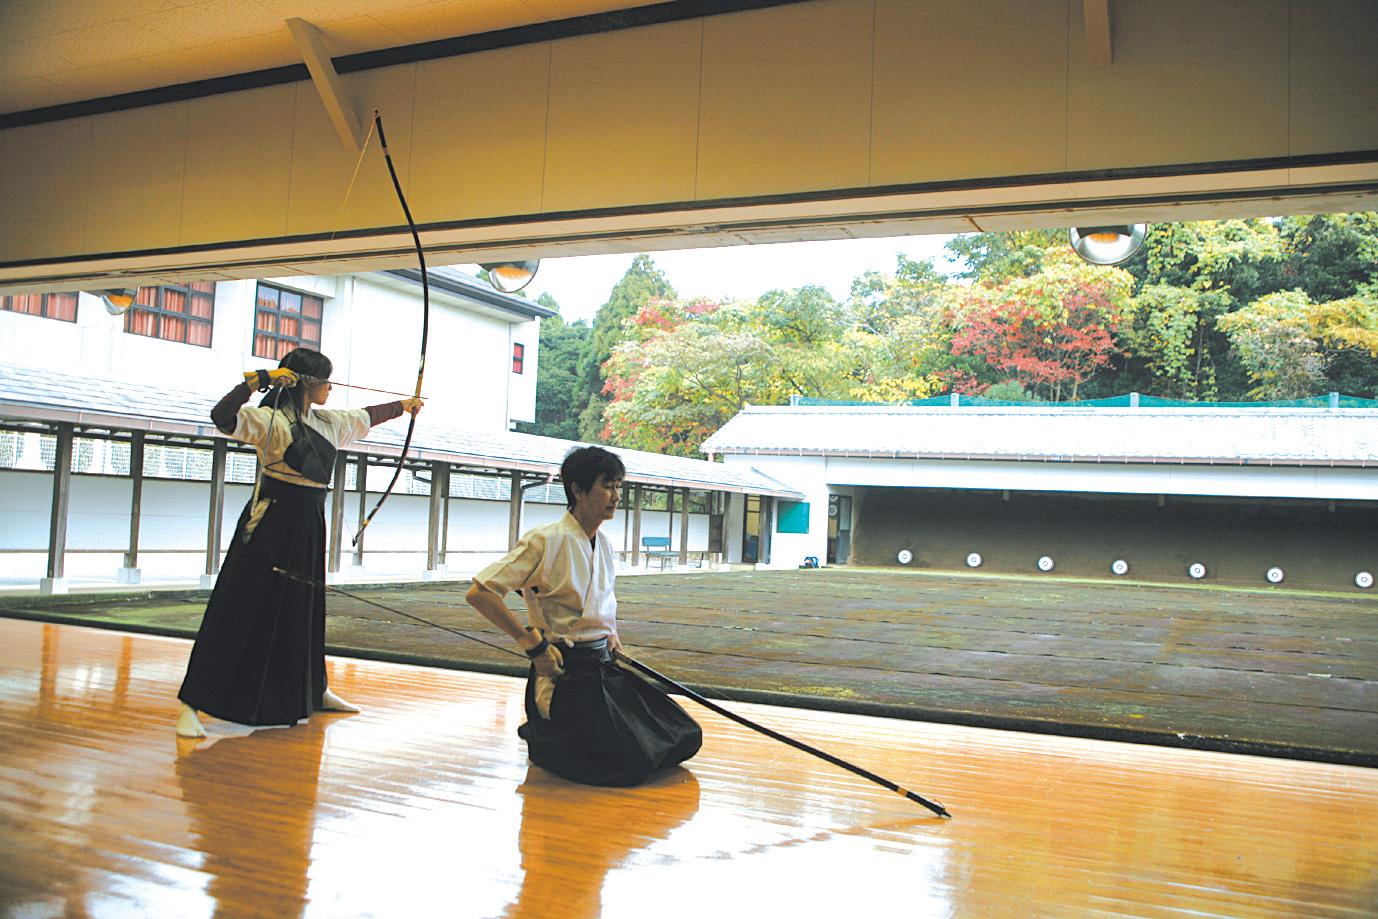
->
[[474, 511, 617, 642]]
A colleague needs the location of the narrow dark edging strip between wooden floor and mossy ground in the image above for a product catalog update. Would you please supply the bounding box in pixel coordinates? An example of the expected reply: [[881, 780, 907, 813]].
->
[[0, 609, 1378, 769]]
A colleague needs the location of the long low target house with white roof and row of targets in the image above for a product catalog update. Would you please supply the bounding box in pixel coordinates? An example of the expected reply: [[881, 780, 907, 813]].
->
[[703, 397, 1378, 590]]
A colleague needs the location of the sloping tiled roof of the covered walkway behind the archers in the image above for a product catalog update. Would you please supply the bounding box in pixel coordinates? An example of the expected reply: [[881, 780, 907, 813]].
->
[[0, 365, 801, 499]]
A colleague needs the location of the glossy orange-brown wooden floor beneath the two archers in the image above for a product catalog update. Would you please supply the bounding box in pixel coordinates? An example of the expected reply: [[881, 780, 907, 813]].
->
[[0, 620, 1378, 919]]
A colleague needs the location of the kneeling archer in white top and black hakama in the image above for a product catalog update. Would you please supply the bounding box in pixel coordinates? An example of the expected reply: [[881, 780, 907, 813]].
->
[[467, 446, 703, 785]]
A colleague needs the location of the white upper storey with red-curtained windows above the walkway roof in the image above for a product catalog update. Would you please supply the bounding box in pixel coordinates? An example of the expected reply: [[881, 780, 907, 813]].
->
[[0, 269, 553, 431]]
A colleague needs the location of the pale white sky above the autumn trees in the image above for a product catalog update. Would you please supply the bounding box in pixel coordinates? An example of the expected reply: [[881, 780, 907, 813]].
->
[[524, 236, 955, 322]]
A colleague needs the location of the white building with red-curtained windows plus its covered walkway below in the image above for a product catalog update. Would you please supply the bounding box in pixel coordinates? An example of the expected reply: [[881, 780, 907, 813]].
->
[[0, 269, 799, 592]]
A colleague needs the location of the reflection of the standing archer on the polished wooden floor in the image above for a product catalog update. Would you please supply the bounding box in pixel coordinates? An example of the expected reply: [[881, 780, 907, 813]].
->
[[176, 718, 328, 919]]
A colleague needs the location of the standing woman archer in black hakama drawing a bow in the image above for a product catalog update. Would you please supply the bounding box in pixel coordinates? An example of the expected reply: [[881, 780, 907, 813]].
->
[[176, 347, 422, 737]]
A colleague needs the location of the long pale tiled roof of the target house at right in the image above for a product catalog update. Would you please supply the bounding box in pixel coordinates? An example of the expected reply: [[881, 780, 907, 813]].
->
[[701, 405, 1378, 466]]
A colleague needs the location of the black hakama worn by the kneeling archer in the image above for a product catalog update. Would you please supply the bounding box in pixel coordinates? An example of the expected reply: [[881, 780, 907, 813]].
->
[[517, 639, 703, 785]]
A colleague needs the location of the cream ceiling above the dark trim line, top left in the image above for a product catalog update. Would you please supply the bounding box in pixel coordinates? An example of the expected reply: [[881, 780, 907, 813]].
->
[[0, 0, 646, 114]]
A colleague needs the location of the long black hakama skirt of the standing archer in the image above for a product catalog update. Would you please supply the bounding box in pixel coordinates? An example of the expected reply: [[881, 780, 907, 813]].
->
[[178, 475, 327, 725]]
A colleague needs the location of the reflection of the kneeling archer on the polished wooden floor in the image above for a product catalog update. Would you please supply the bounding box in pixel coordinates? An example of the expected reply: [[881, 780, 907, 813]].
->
[[504, 766, 699, 919]]
